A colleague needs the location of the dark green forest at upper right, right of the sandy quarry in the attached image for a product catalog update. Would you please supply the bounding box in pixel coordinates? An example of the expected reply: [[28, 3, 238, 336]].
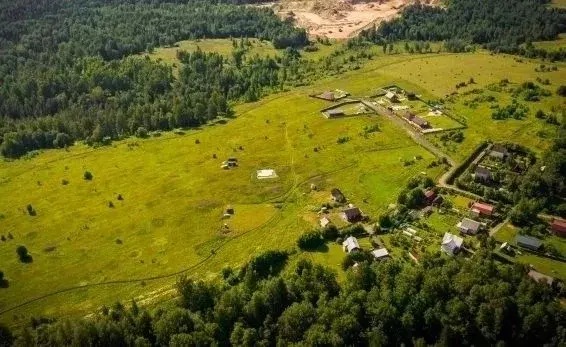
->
[[361, 0, 566, 57]]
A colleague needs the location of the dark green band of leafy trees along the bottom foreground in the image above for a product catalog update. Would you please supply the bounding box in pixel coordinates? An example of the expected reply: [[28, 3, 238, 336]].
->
[[0, 250, 566, 346]]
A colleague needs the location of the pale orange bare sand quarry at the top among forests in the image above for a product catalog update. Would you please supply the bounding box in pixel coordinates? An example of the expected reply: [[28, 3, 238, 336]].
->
[[270, 0, 438, 39]]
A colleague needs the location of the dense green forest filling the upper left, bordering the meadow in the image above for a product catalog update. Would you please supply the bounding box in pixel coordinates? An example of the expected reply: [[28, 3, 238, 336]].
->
[[0, 0, 307, 157]]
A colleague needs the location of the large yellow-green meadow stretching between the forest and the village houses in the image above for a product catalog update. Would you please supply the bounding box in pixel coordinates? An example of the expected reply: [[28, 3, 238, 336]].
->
[[0, 47, 565, 324]]
